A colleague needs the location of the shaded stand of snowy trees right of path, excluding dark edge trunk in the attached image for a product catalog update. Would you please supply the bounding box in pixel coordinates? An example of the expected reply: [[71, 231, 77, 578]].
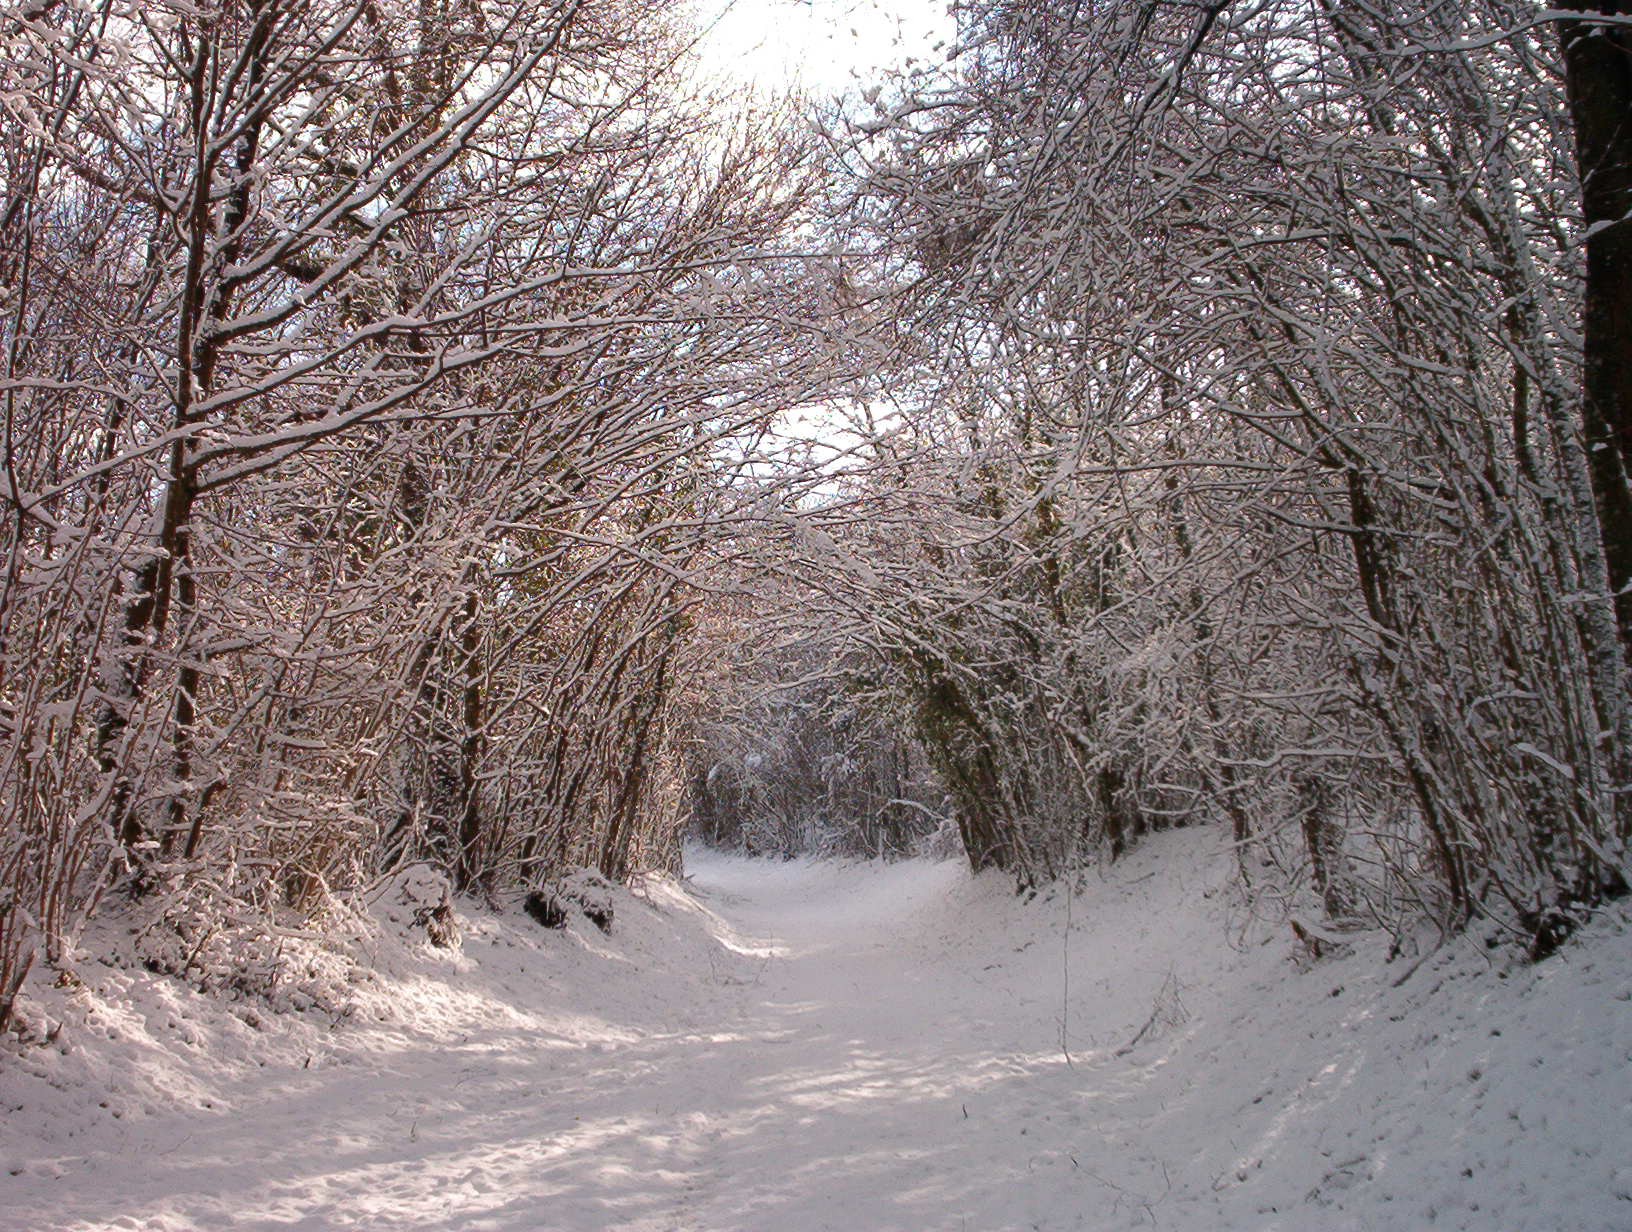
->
[[806, 0, 1627, 927]]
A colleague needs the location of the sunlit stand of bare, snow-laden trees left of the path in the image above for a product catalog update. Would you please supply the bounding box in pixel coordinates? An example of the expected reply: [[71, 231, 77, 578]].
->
[[0, 0, 818, 1010]]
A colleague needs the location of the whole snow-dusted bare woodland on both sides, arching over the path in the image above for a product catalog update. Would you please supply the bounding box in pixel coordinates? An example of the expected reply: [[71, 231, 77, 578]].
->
[[0, 0, 1632, 1037]]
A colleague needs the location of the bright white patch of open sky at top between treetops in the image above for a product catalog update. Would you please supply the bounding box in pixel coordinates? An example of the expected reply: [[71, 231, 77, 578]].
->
[[697, 0, 951, 93]]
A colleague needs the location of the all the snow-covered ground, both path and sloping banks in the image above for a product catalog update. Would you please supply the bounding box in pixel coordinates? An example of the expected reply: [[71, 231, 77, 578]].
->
[[0, 831, 1632, 1232]]
